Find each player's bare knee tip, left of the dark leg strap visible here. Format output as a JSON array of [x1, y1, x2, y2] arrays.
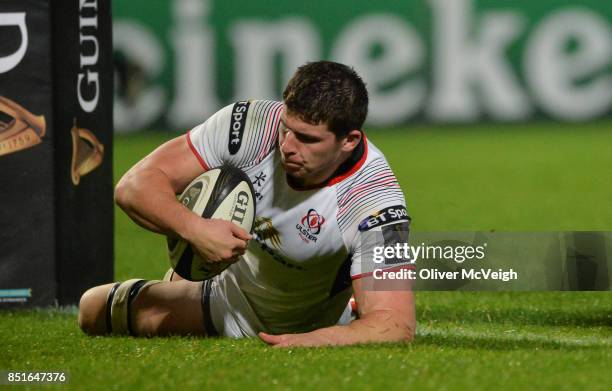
[[79, 284, 113, 335]]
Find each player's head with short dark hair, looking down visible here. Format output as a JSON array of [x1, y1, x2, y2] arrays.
[[279, 61, 368, 186]]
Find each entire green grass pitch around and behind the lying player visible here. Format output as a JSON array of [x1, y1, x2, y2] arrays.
[[0, 123, 612, 390]]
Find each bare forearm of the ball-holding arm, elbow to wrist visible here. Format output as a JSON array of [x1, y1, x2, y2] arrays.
[[115, 169, 193, 236]]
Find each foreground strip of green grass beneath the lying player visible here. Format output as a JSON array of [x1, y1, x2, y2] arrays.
[[0, 292, 612, 390]]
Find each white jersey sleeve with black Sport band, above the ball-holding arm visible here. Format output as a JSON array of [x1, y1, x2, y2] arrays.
[[187, 100, 282, 170]]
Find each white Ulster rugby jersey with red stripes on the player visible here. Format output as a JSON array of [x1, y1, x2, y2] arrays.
[[187, 100, 409, 335]]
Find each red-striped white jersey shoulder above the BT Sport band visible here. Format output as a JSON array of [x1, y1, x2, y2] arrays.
[[336, 140, 407, 234]]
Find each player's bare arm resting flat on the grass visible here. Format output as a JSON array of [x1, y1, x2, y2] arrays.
[[259, 276, 416, 347]]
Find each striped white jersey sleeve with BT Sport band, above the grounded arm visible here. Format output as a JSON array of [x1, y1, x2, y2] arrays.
[[337, 157, 412, 279]]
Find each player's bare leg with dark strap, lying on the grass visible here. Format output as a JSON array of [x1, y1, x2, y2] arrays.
[[79, 280, 204, 336]]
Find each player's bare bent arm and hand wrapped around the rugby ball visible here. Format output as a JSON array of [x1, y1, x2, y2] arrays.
[[115, 136, 250, 261]]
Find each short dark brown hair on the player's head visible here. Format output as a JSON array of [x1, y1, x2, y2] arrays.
[[283, 61, 368, 139]]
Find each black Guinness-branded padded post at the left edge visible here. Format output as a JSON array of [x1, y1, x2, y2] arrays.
[[0, 0, 113, 307]]
